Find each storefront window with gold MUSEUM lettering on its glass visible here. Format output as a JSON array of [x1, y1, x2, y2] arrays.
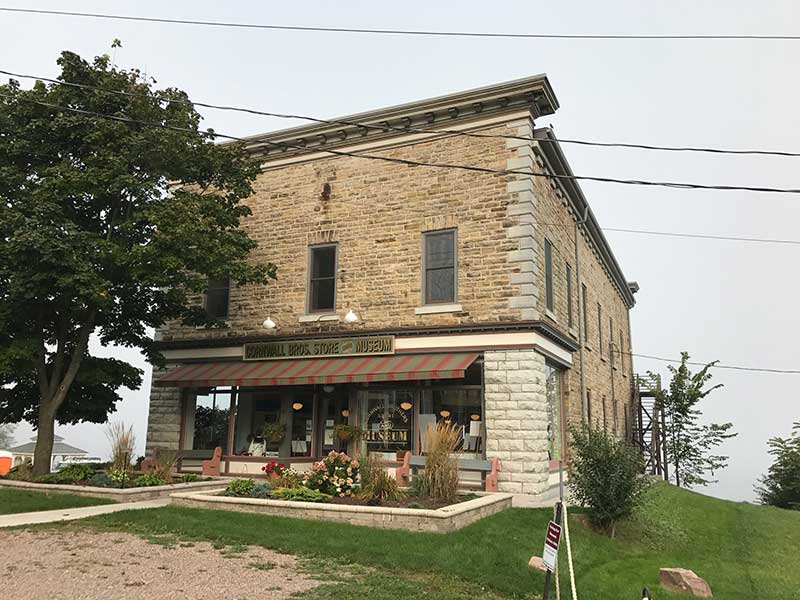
[[361, 389, 416, 453]]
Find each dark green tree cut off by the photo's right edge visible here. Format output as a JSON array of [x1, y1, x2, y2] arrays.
[[756, 421, 800, 510]]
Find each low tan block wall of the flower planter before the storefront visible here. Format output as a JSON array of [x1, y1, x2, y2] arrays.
[[170, 489, 512, 533]]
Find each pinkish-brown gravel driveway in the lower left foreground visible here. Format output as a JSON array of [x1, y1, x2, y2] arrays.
[[0, 530, 320, 600]]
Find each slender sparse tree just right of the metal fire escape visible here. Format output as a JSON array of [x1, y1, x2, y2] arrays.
[[658, 352, 736, 487]]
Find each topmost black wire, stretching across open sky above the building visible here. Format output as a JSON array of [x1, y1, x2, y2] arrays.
[[0, 7, 800, 41]]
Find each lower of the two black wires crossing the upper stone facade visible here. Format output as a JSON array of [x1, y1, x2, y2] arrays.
[[0, 94, 800, 194]]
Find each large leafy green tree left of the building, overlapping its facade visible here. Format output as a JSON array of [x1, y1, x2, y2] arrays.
[[0, 52, 275, 474]]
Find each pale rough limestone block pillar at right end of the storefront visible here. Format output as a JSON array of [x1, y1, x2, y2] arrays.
[[483, 350, 549, 494]]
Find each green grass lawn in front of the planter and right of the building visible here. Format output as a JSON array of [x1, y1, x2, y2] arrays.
[[83, 484, 800, 600]]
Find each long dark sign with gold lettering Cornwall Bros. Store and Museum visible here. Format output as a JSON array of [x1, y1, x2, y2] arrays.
[[242, 335, 394, 360]]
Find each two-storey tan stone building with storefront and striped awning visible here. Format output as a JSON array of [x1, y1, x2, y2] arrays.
[[147, 75, 637, 506]]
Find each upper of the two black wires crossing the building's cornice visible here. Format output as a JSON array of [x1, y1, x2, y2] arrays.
[[6, 69, 800, 157]]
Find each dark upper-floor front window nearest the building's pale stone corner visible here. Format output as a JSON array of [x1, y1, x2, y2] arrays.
[[422, 229, 457, 304]]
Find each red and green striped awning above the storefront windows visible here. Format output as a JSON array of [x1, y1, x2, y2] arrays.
[[153, 353, 478, 387]]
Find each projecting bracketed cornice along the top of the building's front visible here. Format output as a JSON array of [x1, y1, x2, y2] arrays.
[[230, 75, 558, 163]]
